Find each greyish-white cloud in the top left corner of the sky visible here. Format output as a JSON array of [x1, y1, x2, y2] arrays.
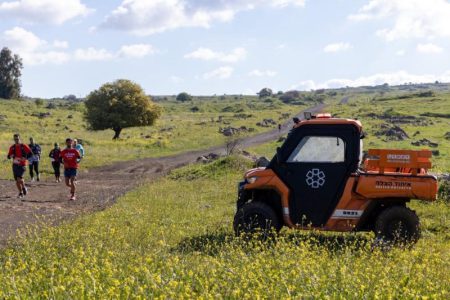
[[0, 0, 92, 24]]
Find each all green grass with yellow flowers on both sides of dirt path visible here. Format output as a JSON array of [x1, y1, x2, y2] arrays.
[[0, 86, 450, 299]]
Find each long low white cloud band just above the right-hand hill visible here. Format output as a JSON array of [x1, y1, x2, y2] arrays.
[[291, 70, 450, 90]]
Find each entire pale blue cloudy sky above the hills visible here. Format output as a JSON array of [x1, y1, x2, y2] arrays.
[[0, 0, 450, 97]]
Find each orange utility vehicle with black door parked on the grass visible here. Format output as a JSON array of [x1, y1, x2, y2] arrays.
[[234, 114, 438, 242]]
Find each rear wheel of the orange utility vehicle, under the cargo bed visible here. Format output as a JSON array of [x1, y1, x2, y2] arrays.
[[375, 206, 420, 245]]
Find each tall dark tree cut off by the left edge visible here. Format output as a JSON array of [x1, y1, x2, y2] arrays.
[[0, 47, 23, 99]]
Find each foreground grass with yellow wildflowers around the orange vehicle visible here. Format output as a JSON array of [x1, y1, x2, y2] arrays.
[[0, 158, 450, 299]]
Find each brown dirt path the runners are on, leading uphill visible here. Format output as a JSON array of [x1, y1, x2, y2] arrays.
[[0, 105, 324, 246]]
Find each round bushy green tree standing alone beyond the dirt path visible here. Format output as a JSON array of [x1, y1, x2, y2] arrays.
[[85, 79, 161, 139]]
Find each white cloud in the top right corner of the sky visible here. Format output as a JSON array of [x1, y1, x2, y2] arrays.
[[348, 0, 450, 41]]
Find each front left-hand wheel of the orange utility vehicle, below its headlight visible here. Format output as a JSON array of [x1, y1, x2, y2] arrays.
[[233, 202, 282, 240]]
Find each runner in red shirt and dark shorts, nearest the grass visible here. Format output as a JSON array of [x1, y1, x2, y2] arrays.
[[59, 138, 81, 201]]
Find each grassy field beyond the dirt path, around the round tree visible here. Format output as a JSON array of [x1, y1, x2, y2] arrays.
[[0, 96, 307, 178]]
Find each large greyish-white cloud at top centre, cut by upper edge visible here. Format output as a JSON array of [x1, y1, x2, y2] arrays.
[[100, 0, 305, 35]]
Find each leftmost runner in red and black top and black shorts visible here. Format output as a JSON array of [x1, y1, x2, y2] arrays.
[[8, 133, 32, 198]]
